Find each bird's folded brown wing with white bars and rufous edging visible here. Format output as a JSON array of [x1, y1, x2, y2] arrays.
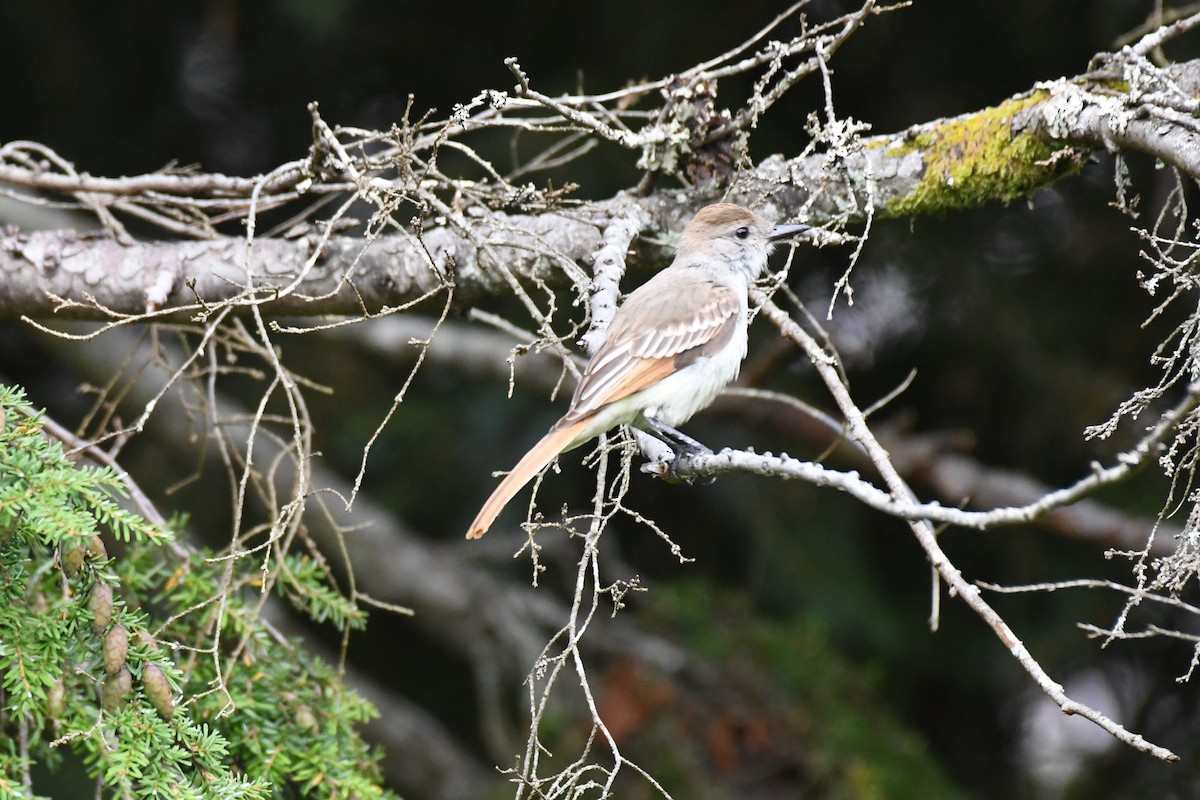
[[563, 270, 740, 423]]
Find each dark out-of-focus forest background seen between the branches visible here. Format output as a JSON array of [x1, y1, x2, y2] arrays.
[[0, 0, 1200, 799]]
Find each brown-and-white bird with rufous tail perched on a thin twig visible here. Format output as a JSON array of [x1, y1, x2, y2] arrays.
[[467, 203, 810, 539]]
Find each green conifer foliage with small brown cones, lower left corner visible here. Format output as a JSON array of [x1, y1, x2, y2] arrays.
[[0, 386, 390, 799]]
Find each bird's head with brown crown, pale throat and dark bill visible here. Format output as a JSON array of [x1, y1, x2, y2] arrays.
[[676, 203, 809, 279]]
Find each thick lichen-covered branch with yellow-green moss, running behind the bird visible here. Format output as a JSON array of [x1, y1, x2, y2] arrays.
[[7, 52, 1200, 321]]
